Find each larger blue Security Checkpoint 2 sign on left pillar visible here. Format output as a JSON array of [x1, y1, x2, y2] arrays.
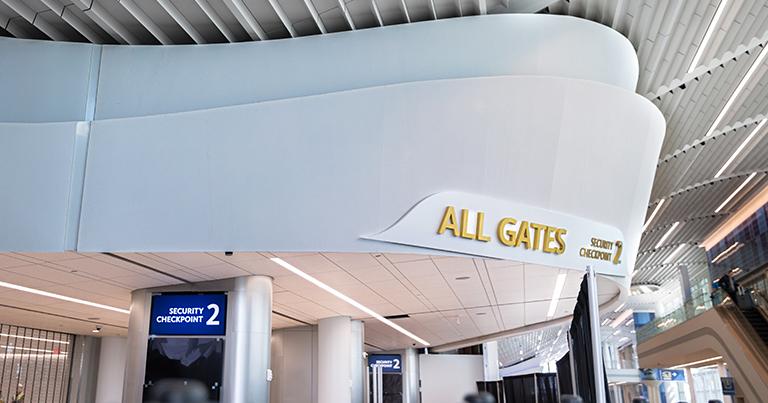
[[149, 293, 227, 336]]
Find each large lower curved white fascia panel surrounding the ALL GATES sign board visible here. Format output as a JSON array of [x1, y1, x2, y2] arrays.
[[79, 77, 664, 290]]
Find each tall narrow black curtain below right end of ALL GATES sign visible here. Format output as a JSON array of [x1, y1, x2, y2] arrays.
[[558, 275, 611, 403]]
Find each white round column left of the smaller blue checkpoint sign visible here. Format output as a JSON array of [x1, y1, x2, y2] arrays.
[[317, 316, 353, 403]]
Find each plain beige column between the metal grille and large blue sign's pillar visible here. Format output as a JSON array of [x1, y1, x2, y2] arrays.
[[96, 337, 128, 403]]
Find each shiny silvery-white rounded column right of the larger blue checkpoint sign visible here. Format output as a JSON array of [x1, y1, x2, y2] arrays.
[[222, 276, 272, 403]]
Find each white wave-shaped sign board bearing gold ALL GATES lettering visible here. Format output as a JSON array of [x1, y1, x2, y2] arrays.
[[363, 192, 628, 277]]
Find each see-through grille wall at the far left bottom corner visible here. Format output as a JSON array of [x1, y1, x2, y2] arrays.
[[0, 324, 74, 403]]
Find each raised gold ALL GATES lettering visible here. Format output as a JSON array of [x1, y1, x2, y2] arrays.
[[437, 206, 568, 255]]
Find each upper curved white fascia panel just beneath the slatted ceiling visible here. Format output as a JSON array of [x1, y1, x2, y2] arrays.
[[96, 14, 638, 119]]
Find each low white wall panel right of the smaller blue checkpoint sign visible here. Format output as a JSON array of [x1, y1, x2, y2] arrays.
[[419, 354, 483, 403]]
